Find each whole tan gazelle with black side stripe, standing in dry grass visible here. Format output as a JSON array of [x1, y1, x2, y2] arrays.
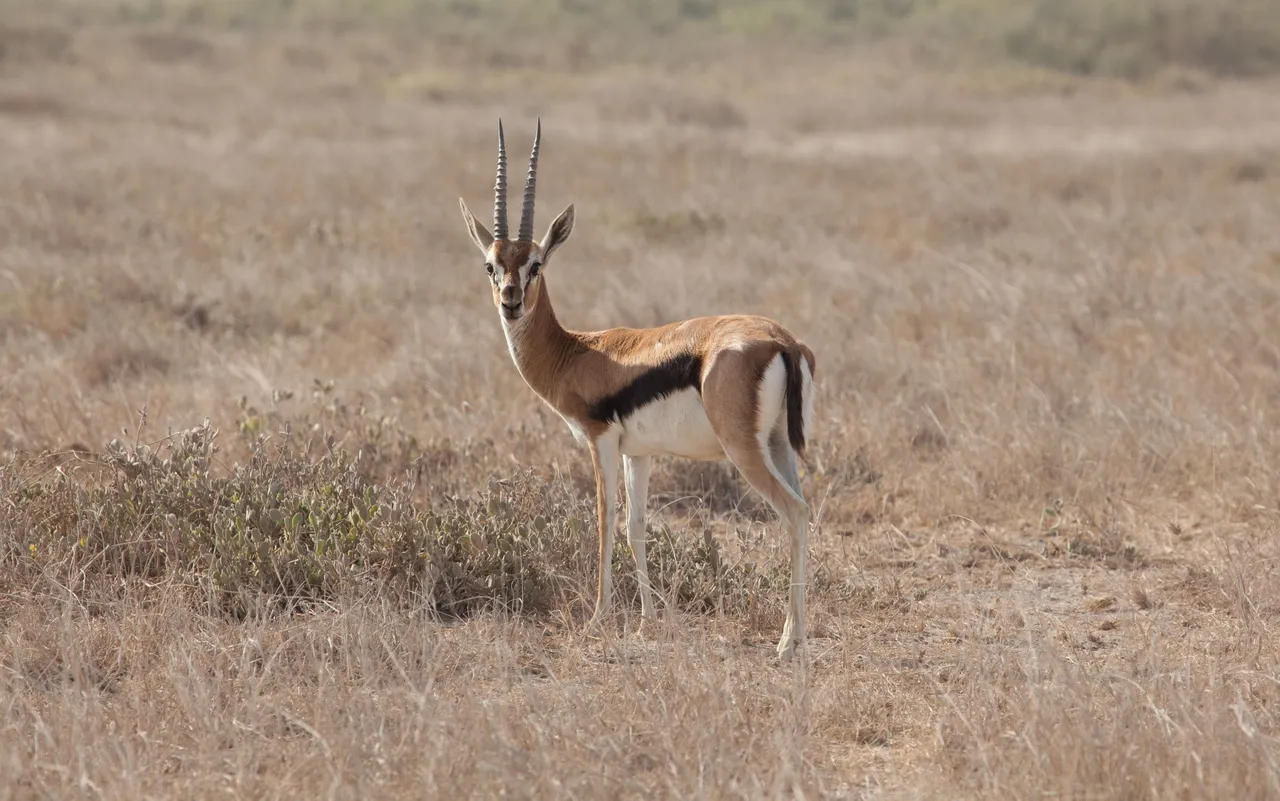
[[458, 120, 814, 660]]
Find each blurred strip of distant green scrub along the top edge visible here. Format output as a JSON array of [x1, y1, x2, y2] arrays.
[[17, 0, 1280, 79]]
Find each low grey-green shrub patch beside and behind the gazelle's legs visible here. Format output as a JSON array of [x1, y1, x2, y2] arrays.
[[0, 421, 787, 618]]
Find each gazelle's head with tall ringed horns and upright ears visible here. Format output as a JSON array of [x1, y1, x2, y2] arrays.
[[458, 119, 573, 324]]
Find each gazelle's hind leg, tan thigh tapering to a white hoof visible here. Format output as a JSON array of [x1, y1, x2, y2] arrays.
[[703, 351, 809, 660]]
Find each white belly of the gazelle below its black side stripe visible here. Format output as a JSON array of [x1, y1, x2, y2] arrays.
[[621, 388, 724, 461]]
